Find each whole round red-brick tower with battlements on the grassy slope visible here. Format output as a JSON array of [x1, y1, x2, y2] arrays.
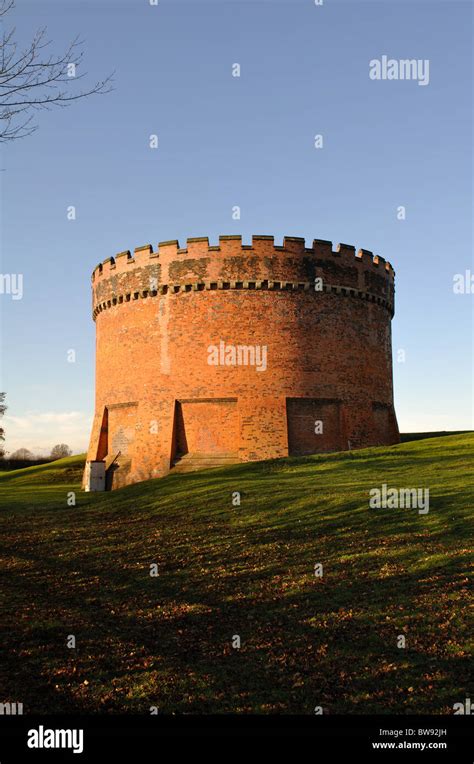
[[87, 236, 399, 488]]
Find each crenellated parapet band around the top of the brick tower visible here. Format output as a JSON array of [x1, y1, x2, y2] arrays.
[[92, 236, 395, 318]]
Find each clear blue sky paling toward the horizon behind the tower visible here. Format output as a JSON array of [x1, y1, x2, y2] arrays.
[[0, 0, 474, 454]]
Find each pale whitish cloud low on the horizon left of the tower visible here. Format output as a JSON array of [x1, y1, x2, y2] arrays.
[[2, 411, 92, 456]]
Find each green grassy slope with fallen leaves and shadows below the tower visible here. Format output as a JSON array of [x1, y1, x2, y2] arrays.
[[0, 434, 474, 714]]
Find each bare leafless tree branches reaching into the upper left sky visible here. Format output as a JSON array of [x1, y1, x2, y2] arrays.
[[0, 0, 112, 142]]
